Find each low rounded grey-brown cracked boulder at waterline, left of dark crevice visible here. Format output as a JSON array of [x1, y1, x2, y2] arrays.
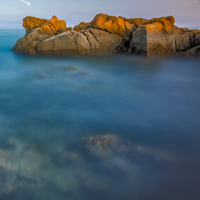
[[37, 29, 122, 55]]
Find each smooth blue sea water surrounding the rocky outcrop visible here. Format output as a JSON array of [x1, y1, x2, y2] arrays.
[[0, 30, 200, 200]]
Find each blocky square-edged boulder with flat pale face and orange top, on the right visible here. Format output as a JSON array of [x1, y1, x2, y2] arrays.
[[129, 16, 176, 56]]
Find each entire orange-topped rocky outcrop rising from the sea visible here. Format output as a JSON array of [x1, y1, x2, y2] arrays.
[[13, 14, 200, 56]]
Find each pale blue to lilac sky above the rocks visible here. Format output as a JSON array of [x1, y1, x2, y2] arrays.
[[0, 0, 200, 29]]
